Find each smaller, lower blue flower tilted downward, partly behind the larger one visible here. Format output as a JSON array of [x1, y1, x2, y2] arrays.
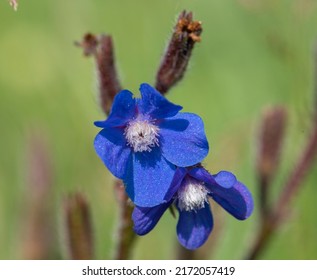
[[132, 167, 253, 250]]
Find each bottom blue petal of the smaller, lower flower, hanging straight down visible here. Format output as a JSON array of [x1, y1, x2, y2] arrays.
[[177, 202, 213, 250]]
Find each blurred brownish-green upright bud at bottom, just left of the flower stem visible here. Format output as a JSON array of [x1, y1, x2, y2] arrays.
[[64, 193, 94, 260]]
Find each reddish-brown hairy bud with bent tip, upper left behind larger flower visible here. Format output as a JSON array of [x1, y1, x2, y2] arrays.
[[75, 33, 122, 114]]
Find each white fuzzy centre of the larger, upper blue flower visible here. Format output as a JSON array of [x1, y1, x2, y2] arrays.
[[124, 120, 159, 152]]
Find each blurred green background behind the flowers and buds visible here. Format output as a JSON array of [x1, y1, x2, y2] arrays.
[[0, 0, 317, 259]]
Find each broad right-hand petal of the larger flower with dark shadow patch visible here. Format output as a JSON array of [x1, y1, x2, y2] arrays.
[[159, 113, 209, 167]]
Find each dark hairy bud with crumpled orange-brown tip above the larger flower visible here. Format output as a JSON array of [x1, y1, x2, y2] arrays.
[[155, 11, 202, 94]]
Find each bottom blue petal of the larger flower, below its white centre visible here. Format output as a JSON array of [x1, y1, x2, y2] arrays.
[[124, 147, 176, 207]]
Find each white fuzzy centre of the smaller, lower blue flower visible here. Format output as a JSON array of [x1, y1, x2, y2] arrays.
[[177, 179, 208, 211]]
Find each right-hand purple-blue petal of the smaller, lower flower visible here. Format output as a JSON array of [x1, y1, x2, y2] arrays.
[[210, 181, 253, 220]]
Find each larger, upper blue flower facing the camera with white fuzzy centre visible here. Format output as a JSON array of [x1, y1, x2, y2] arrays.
[[94, 84, 209, 207]]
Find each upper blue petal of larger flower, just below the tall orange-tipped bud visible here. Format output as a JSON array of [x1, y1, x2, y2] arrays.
[[139, 84, 182, 119]]
